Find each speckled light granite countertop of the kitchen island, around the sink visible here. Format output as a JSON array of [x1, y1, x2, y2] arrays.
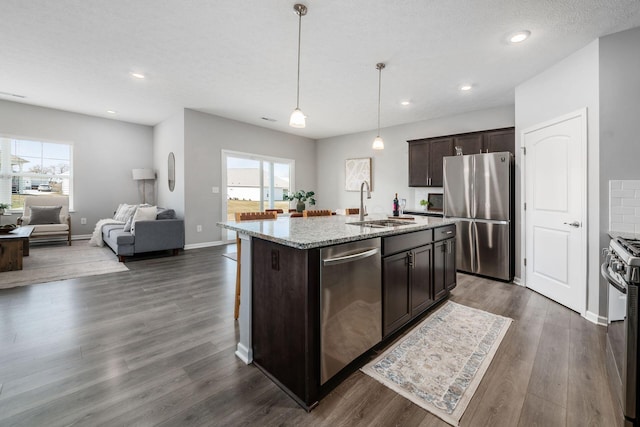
[[217, 214, 455, 249]]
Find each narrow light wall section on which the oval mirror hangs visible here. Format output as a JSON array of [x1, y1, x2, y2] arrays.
[[153, 110, 185, 218]]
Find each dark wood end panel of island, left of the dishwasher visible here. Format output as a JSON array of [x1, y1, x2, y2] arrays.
[[252, 238, 320, 409]]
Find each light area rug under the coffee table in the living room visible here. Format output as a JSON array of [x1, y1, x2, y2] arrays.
[[0, 240, 129, 289]]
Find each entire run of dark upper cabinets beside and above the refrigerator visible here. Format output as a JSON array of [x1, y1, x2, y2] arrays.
[[407, 128, 515, 187]]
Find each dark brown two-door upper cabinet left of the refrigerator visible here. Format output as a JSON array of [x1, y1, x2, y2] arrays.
[[409, 138, 454, 187]]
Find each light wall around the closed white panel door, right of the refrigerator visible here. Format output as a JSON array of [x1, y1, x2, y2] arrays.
[[515, 40, 608, 317]]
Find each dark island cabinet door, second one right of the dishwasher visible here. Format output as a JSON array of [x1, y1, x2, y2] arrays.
[[409, 245, 433, 317]]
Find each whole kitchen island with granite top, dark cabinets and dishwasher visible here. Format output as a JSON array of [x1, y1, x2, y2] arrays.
[[218, 215, 456, 410]]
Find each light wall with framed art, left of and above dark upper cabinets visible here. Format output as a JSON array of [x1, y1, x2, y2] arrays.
[[316, 105, 514, 214]]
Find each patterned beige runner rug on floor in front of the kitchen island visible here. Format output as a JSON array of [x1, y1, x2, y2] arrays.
[[361, 301, 513, 426]]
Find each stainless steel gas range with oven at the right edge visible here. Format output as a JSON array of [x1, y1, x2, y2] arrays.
[[600, 237, 640, 426]]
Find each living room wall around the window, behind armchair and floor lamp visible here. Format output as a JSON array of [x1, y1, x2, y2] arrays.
[[0, 100, 153, 235]]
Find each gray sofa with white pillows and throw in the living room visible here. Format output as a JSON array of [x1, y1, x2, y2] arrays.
[[102, 211, 184, 262]]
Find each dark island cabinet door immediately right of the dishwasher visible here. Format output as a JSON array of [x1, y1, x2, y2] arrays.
[[382, 252, 411, 337]]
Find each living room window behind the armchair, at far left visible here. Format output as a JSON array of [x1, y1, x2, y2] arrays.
[[0, 137, 73, 210]]
